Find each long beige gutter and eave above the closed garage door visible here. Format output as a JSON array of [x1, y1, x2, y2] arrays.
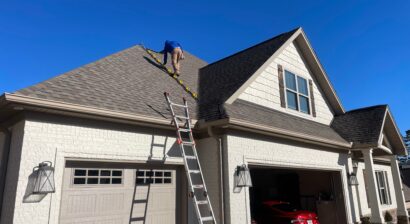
[[0, 93, 187, 129]]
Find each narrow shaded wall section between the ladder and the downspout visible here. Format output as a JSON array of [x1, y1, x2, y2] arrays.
[[196, 138, 222, 223]]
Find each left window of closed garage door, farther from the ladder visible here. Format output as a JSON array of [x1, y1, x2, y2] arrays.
[[72, 169, 123, 185]]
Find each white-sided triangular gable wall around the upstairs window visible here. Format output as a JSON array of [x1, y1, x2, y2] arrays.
[[239, 43, 333, 124]]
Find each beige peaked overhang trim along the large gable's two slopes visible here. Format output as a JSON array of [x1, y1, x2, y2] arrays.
[[225, 28, 345, 115]]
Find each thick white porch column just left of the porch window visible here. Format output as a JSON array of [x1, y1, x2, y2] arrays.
[[362, 149, 384, 224]]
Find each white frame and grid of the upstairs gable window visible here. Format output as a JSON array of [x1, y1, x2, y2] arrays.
[[283, 68, 312, 116]]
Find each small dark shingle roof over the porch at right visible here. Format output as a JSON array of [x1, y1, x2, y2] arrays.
[[331, 105, 387, 145]]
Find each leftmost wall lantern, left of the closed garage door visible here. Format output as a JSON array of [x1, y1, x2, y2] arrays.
[[33, 161, 55, 194]]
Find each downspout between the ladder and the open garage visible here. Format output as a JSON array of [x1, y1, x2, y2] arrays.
[[208, 126, 226, 224]]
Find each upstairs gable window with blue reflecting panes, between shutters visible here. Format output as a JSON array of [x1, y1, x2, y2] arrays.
[[285, 70, 310, 114]]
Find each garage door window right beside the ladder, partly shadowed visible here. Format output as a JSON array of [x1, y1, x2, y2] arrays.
[[136, 170, 172, 184]]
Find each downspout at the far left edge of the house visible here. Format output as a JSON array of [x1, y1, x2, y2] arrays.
[[0, 125, 12, 219]]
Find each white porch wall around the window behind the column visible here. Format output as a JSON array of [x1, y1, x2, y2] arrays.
[[356, 162, 397, 216]]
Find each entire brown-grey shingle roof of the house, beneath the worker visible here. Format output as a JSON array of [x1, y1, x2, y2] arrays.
[[15, 29, 386, 149]]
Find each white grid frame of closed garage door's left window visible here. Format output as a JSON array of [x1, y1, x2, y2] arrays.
[[70, 168, 124, 187]]
